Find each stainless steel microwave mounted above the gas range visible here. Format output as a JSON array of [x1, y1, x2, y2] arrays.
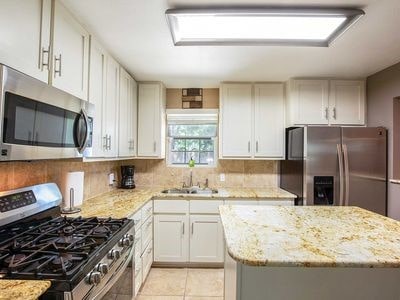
[[0, 65, 94, 161]]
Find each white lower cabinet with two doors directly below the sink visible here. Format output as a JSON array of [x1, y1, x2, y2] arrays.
[[154, 200, 224, 263]]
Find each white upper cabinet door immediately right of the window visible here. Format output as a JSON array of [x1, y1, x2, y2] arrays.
[[220, 84, 253, 158]]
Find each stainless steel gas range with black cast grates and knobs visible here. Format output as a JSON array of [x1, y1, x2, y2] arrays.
[[0, 184, 135, 300]]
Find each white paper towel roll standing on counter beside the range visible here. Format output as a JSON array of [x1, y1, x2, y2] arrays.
[[61, 172, 85, 208]]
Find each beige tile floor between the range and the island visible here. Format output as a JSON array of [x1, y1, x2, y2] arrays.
[[136, 268, 224, 300]]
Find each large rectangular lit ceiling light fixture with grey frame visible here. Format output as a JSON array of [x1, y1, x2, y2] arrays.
[[165, 8, 364, 47]]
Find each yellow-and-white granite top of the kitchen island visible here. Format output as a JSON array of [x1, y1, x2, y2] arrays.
[[220, 205, 400, 268]]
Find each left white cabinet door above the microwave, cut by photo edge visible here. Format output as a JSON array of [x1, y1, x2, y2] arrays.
[[0, 0, 51, 83]]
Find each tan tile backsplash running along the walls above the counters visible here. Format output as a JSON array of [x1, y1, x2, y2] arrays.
[[0, 160, 278, 199]]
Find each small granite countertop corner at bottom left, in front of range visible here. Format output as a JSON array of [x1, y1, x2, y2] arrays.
[[0, 279, 51, 300]]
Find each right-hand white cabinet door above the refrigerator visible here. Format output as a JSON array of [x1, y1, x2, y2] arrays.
[[329, 80, 365, 125]]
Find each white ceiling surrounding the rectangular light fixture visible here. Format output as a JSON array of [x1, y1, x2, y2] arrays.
[[63, 0, 400, 87]]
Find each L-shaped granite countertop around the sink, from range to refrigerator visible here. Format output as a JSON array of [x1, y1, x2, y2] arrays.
[[67, 187, 296, 218]]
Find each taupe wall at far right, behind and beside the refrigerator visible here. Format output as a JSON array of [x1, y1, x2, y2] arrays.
[[367, 63, 400, 220]]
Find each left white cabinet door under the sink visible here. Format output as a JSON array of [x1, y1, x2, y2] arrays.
[[154, 215, 189, 262]]
